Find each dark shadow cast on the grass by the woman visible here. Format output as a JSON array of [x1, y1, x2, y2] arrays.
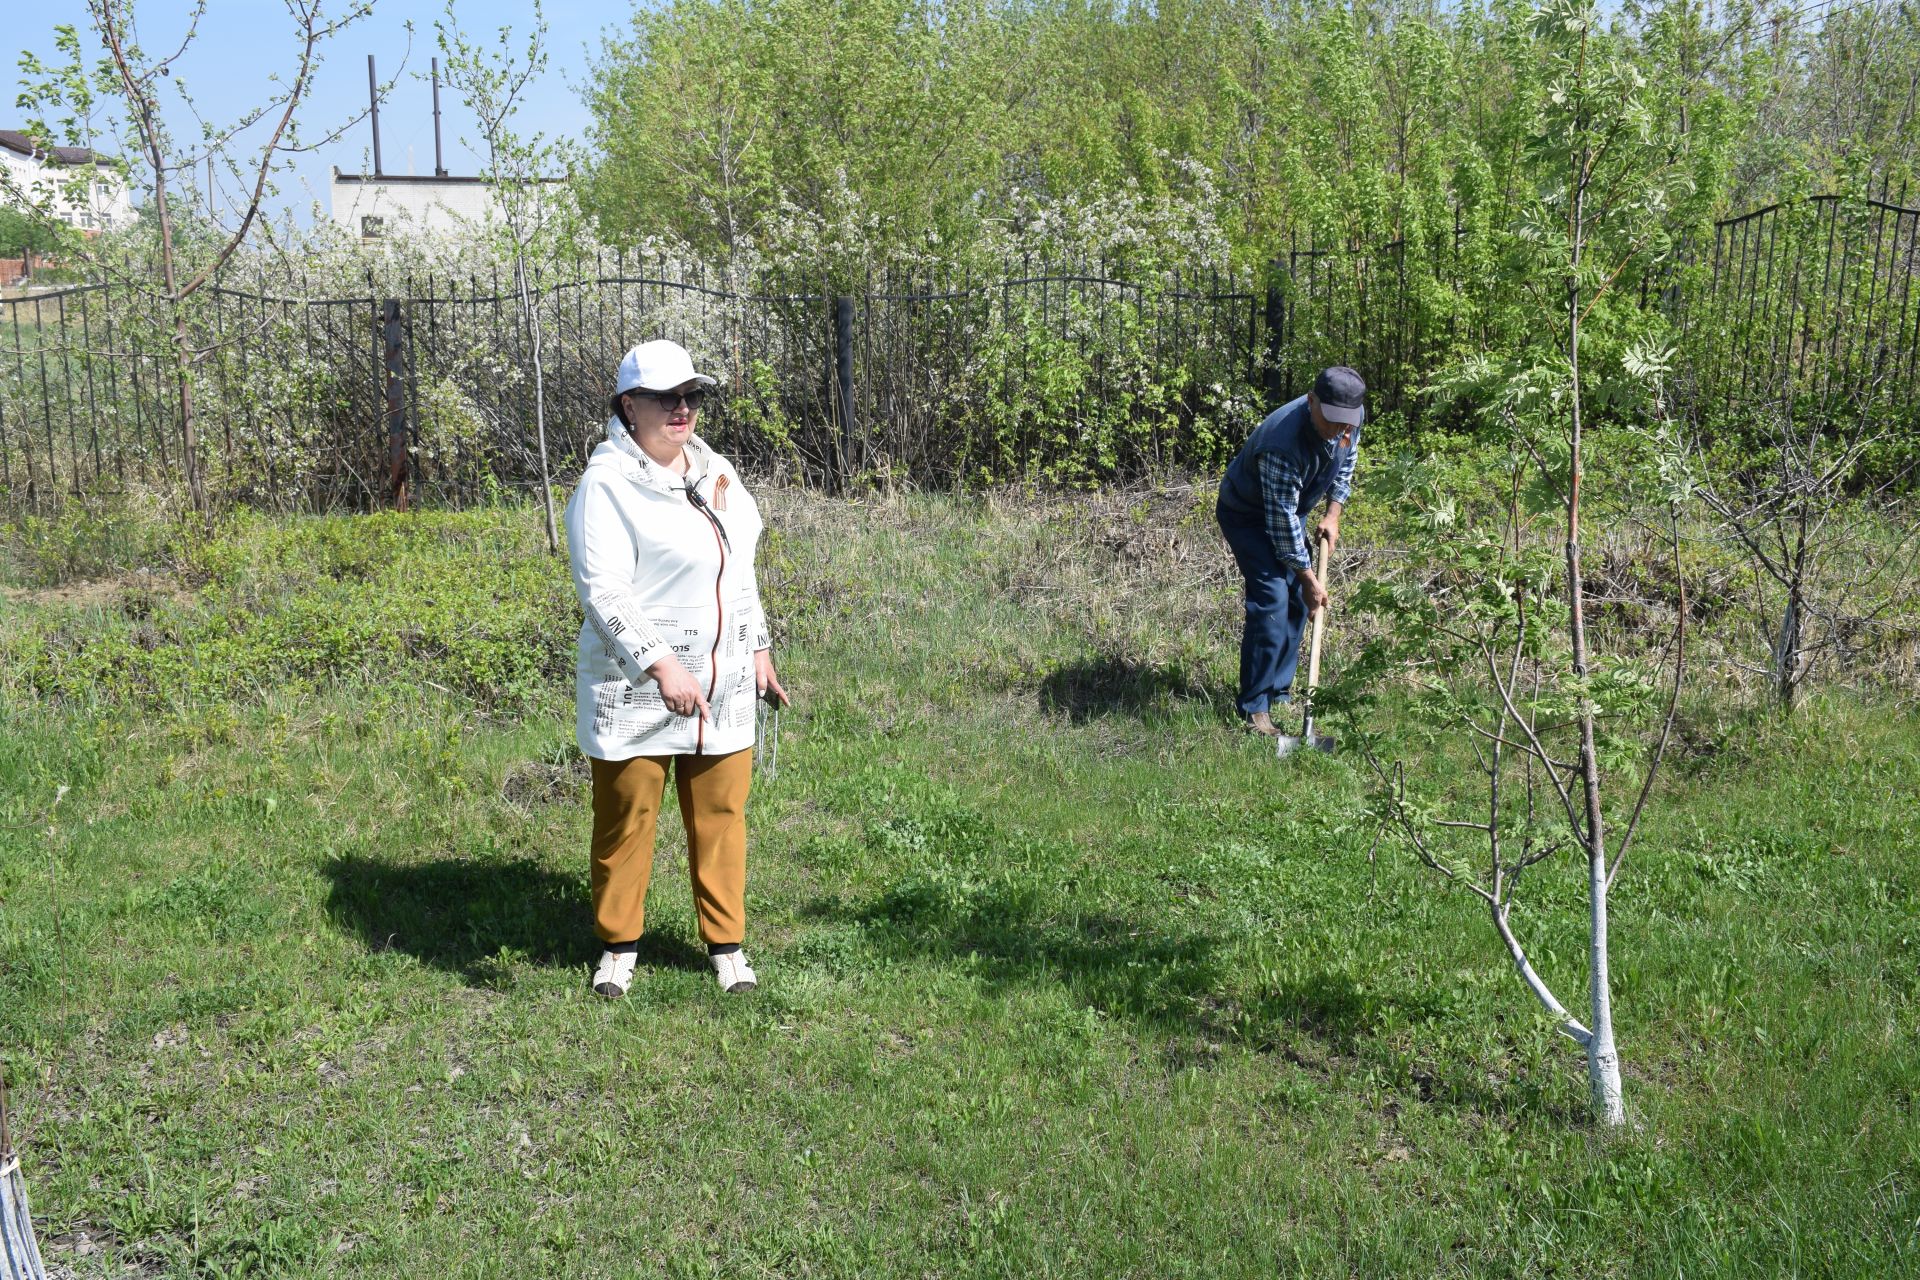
[[323, 856, 707, 984]]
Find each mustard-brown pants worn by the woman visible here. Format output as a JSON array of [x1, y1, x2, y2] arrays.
[[589, 748, 753, 944]]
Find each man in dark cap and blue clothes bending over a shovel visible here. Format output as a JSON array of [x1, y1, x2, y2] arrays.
[[1213, 365, 1367, 737]]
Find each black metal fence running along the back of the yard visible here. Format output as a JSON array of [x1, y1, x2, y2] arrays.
[[0, 198, 1920, 509]]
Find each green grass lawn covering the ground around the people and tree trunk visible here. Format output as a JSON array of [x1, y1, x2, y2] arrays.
[[0, 491, 1920, 1278]]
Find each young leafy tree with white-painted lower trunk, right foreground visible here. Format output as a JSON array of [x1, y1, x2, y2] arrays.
[[1356, 0, 1690, 1126]]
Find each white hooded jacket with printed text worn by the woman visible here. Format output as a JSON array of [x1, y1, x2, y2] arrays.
[[566, 418, 772, 760]]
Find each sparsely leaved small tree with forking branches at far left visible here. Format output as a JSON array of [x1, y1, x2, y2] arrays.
[[9, 0, 393, 514]]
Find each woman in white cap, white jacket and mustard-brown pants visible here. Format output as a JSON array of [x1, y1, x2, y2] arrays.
[[566, 342, 787, 996]]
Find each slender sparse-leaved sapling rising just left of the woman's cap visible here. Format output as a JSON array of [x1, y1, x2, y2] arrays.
[[436, 0, 578, 553]]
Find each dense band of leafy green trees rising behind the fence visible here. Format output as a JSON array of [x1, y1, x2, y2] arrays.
[[586, 0, 1881, 280]]
